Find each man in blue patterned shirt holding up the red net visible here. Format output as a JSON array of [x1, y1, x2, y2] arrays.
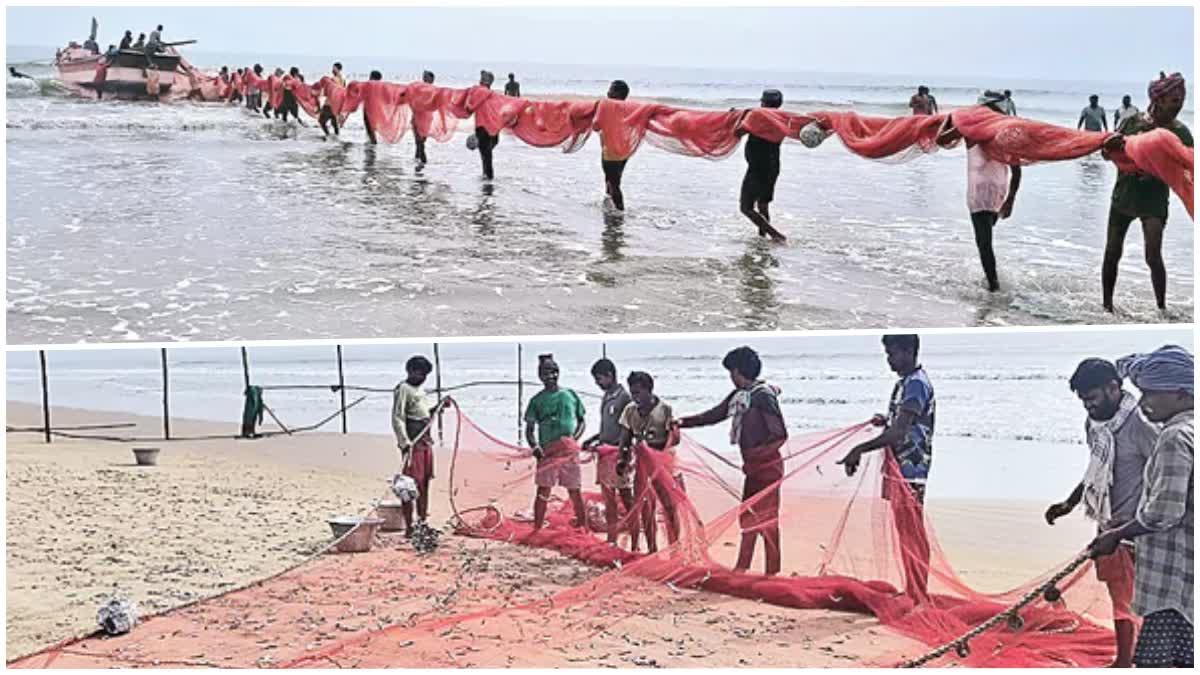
[[838, 335, 936, 597]]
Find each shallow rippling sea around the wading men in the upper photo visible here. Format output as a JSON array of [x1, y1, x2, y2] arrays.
[[6, 54, 1194, 344]]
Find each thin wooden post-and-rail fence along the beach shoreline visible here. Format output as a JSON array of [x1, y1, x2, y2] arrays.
[[6, 342, 607, 446]]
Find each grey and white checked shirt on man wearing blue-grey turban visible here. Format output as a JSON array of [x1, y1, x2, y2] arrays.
[[1133, 411, 1195, 626]]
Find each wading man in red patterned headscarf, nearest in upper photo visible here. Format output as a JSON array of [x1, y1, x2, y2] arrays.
[[1100, 73, 1193, 312]]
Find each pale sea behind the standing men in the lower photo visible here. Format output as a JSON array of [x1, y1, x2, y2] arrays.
[[6, 327, 1193, 501]]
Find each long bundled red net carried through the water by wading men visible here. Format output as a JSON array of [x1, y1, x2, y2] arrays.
[[174, 63, 1195, 214]]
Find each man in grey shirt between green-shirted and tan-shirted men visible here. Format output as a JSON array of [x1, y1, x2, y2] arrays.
[[583, 358, 637, 545]]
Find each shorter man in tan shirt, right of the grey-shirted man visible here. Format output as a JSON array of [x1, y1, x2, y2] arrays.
[[617, 370, 684, 552]]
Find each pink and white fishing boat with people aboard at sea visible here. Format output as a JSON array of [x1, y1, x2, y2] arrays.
[[54, 19, 196, 101]]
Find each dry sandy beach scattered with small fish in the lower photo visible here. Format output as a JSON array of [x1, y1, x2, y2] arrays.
[[6, 402, 1099, 667]]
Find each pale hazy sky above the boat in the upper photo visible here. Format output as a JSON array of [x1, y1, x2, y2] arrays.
[[5, 6, 1194, 82]]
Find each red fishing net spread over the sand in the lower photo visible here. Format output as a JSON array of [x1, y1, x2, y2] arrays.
[[14, 404, 1114, 668]]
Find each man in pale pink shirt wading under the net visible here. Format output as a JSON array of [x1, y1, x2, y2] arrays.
[[938, 89, 1021, 293]]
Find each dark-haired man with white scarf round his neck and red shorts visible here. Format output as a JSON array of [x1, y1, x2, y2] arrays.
[[1045, 359, 1158, 668]]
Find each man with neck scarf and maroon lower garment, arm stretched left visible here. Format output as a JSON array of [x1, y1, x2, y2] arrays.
[[678, 347, 787, 575]]
